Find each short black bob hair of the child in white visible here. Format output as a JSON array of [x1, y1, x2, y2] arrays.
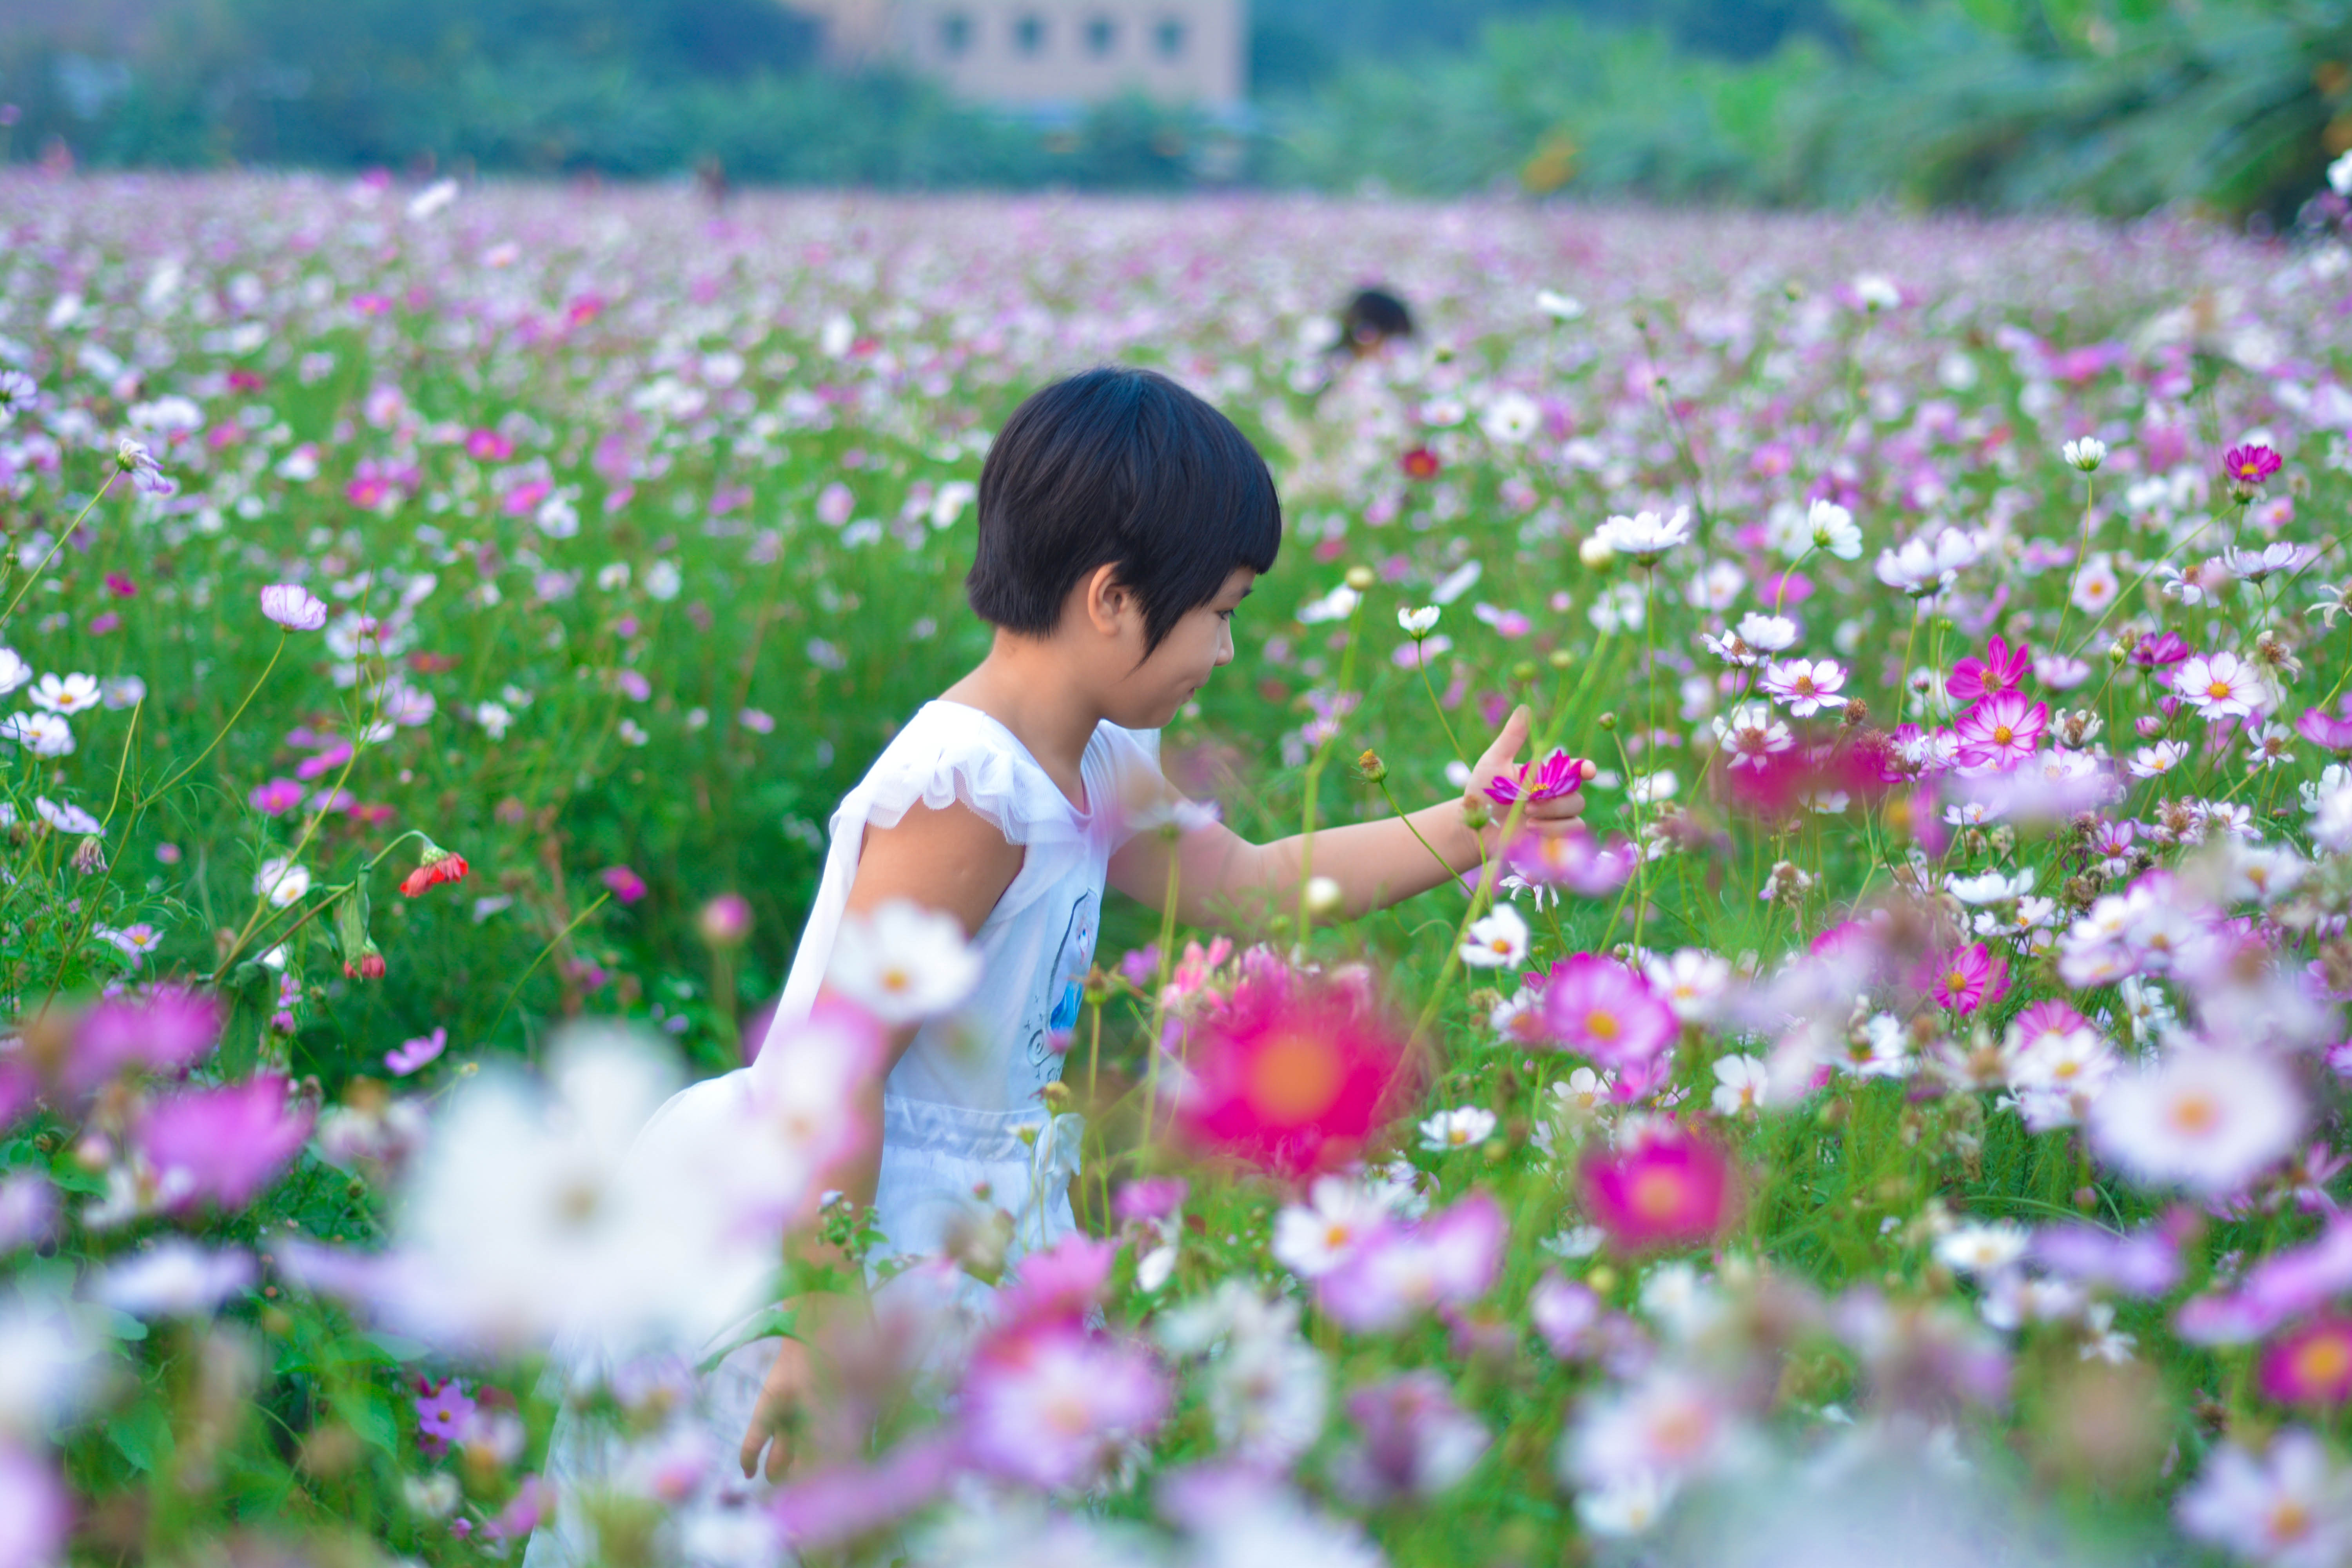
[[964, 365, 1282, 653]]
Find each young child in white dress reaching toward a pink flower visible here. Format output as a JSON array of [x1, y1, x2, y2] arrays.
[[532, 369, 1581, 1568]]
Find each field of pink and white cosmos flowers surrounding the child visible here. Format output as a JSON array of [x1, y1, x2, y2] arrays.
[[0, 167, 2352, 1568]]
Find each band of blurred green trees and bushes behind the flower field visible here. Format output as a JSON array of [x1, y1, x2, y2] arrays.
[[0, 0, 2352, 219]]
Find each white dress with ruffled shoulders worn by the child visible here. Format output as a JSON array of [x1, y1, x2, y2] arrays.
[[524, 698, 1164, 1568]]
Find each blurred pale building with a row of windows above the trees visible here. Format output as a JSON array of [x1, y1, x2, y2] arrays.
[[786, 0, 1249, 108]]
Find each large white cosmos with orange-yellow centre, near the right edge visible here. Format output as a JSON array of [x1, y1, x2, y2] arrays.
[[2091, 1042, 2303, 1194]]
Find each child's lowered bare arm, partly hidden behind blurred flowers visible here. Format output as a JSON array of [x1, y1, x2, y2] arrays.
[[739, 804, 1023, 1481]]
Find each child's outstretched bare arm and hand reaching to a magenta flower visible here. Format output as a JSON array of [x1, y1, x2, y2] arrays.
[[1110, 708, 1592, 926]]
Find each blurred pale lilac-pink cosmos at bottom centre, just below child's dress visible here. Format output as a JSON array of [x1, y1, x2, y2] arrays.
[[962, 1328, 1169, 1490]]
